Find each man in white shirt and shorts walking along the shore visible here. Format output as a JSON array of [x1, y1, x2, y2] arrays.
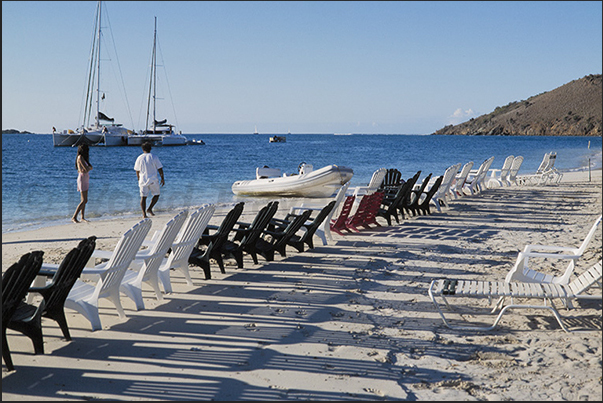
[[134, 141, 165, 218]]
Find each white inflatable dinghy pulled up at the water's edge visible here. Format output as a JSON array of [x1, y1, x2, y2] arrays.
[[232, 162, 354, 197]]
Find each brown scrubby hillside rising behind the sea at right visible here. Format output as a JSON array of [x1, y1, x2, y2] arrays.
[[432, 74, 603, 136]]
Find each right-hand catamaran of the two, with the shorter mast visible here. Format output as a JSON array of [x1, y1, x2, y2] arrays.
[[128, 17, 188, 146]]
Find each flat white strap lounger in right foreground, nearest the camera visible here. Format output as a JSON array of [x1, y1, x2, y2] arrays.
[[428, 261, 601, 332]]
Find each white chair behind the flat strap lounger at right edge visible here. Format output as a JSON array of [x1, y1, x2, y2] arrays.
[[505, 216, 603, 284]]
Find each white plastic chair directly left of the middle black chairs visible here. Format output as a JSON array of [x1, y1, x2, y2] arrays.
[[159, 204, 216, 293]]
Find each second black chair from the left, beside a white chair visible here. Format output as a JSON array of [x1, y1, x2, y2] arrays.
[[8, 236, 96, 354]]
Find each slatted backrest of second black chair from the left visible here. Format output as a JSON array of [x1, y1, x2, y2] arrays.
[[44, 236, 96, 311]]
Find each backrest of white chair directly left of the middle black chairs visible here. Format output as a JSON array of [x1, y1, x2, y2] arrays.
[[167, 204, 216, 268]]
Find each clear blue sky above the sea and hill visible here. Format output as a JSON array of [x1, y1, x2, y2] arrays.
[[2, 1, 603, 134]]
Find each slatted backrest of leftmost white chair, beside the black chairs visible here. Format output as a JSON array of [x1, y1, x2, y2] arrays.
[[95, 218, 153, 298]]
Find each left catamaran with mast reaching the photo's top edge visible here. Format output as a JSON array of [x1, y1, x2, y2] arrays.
[[52, 1, 133, 147]]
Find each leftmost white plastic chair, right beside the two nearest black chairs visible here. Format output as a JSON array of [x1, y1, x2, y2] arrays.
[[65, 218, 152, 330]]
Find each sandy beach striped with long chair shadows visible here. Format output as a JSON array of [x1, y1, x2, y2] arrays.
[[2, 170, 603, 401]]
